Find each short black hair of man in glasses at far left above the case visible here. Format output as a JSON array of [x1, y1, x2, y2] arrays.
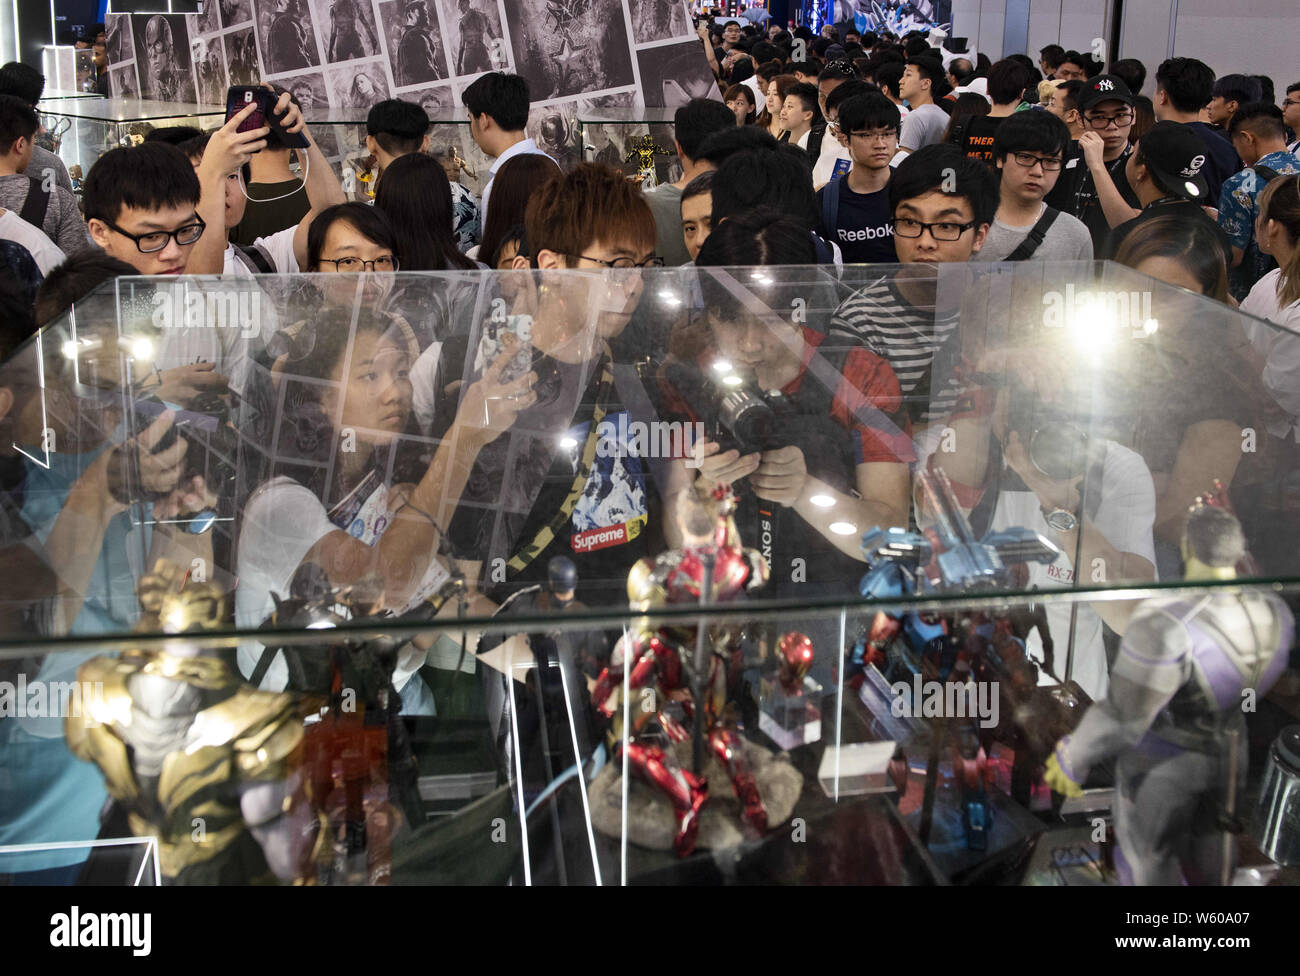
[[82, 143, 199, 221]]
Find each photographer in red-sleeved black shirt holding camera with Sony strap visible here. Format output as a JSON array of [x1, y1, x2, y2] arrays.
[[664, 211, 913, 594]]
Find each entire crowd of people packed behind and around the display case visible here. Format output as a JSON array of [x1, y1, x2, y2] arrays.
[[0, 22, 1300, 879]]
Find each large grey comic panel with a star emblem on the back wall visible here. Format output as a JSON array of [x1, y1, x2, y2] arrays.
[[506, 0, 634, 101]]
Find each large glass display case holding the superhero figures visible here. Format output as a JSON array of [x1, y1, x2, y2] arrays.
[[0, 263, 1300, 885]]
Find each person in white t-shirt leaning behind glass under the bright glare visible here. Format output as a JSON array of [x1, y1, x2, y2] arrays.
[[918, 347, 1156, 699]]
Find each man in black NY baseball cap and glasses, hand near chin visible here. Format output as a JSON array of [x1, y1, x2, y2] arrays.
[[1045, 74, 1138, 253]]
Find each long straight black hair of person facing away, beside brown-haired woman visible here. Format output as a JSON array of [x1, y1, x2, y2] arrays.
[[374, 152, 477, 272]]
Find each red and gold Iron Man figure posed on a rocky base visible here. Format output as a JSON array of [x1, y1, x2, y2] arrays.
[[592, 485, 807, 856]]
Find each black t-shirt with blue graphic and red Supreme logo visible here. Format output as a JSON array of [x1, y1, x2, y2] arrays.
[[447, 356, 654, 607]]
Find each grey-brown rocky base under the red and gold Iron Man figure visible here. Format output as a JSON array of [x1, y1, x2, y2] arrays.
[[590, 739, 803, 851]]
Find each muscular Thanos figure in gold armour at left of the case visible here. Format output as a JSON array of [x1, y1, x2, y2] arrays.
[[66, 561, 317, 884]]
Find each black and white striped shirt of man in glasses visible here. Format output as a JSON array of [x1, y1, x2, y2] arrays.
[[827, 278, 961, 424]]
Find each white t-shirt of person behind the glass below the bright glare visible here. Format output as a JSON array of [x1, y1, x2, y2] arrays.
[[922, 425, 1156, 700]]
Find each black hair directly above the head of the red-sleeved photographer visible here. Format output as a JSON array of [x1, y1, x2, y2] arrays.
[[712, 143, 818, 231]]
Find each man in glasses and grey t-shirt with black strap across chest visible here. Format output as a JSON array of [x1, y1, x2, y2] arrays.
[[975, 112, 1092, 261]]
